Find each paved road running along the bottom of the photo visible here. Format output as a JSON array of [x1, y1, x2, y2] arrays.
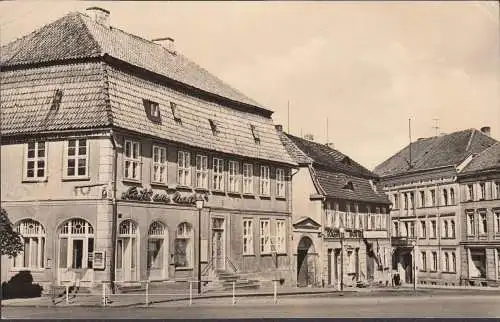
[[2, 295, 500, 319]]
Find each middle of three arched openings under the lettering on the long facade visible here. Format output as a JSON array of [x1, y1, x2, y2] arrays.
[[147, 221, 168, 279]]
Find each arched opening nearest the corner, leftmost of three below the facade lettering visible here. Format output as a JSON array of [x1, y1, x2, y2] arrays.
[[116, 219, 138, 281]]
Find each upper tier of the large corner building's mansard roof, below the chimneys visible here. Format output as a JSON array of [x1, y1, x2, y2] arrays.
[[0, 12, 265, 110]]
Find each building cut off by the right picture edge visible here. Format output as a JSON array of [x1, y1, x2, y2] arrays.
[[458, 143, 500, 286]]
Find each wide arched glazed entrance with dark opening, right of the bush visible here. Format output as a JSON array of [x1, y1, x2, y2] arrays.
[[57, 219, 94, 287]]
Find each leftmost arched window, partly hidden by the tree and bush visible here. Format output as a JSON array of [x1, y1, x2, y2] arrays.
[[13, 219, 45, 268]]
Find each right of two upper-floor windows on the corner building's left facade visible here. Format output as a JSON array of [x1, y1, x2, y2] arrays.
[[64, 139, 88, 178]]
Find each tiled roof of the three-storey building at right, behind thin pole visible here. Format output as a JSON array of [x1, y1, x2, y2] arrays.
[[374, 129, 497, 177]]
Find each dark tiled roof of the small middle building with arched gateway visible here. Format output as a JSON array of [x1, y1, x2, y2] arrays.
[[278, 131, 390, 204]]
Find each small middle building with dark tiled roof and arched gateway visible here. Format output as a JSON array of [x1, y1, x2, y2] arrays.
[[277, 126, 391, 288]]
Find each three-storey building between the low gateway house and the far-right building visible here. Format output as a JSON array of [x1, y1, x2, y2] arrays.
[[374, 129, 496, 285]]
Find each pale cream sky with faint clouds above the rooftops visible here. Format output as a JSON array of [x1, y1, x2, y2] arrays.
[[0, 1, 500, 169]]
